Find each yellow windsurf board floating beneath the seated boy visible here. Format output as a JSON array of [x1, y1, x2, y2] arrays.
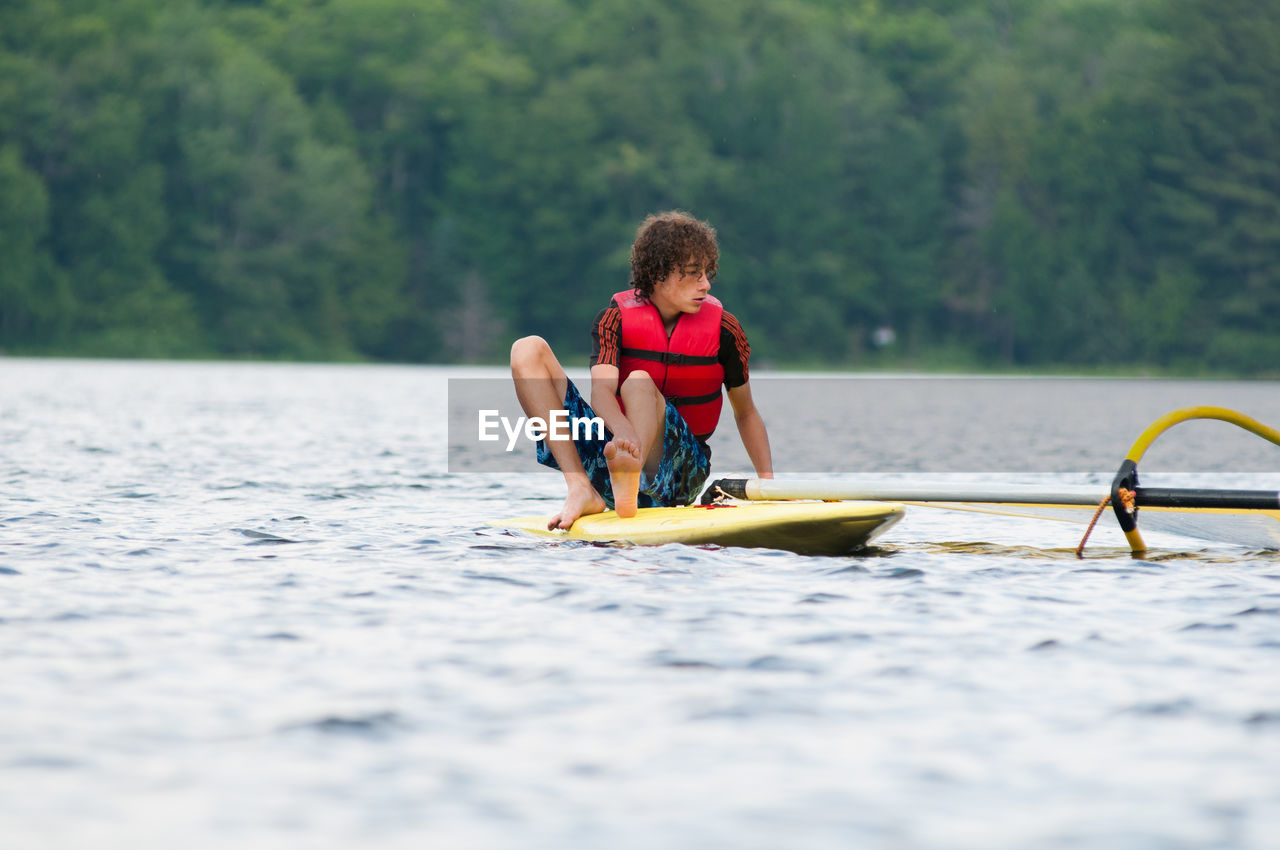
[[489, 502, 904, 554]]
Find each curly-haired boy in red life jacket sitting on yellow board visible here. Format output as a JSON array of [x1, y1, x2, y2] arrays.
[[511, 211, 773, 529]]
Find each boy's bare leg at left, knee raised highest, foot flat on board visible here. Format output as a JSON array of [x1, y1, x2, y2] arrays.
[[511, 337, 604, 529]]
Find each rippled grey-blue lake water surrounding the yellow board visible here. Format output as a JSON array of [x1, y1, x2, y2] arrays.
[[0, 358, 1280, 850]]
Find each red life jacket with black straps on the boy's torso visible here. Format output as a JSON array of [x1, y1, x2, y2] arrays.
[[613, 289, 724, 439]]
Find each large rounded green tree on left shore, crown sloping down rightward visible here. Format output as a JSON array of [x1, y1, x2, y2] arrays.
[[148, 8, 402, 357]]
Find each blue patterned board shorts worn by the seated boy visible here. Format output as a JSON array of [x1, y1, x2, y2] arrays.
[[538, 381, 712, 508]]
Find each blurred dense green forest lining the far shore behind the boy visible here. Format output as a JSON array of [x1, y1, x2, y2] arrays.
[[0, 0, 1280, 374]]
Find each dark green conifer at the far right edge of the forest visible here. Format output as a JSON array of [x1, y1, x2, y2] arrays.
[[1157, 0, 1280, 371]]
